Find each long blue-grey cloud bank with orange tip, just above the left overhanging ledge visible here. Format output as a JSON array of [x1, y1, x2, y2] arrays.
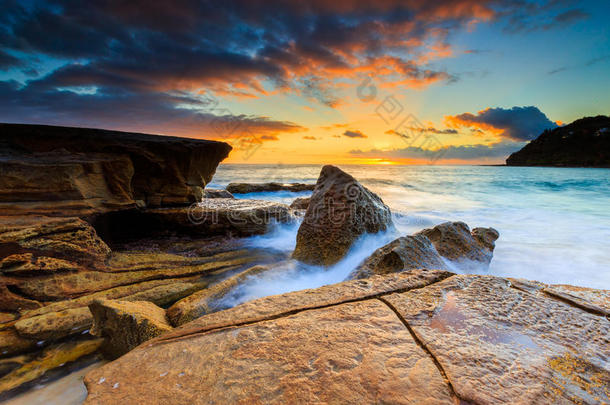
[[0, 82, 306, 140]]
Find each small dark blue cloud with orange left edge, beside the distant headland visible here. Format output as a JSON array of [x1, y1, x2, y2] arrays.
[[445, 106, 557, 141]]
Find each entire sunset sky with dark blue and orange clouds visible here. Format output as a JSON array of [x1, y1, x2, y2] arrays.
[[0, 0, 610, 164]]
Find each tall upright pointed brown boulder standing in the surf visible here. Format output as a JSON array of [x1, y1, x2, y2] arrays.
[[293, 165, 393, 266]]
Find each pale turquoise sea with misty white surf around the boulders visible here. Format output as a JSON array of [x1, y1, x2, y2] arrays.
[[210, 165, 610, 290]]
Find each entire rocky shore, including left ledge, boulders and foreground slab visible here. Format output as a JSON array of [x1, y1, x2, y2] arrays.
[[0, 124, 610, 404]]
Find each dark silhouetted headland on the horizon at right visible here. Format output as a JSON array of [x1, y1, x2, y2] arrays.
[[506, 115, 610, 167]]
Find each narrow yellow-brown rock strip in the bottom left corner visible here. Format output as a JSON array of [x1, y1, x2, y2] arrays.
[[0, 339, 102, 395]]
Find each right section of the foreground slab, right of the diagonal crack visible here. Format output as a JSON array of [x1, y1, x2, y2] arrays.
[[384, 275, 610, 404]]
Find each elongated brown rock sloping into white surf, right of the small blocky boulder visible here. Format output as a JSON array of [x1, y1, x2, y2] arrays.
[[167, 266, 269, 326]]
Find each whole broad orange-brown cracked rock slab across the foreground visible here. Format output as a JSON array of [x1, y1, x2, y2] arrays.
[[85, 270, 610, 404]]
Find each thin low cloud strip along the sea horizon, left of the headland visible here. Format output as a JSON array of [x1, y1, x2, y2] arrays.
[[349, 141, 524, 161]]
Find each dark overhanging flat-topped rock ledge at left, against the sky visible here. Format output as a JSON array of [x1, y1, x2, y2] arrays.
[[0, 124, 231, 217]]
